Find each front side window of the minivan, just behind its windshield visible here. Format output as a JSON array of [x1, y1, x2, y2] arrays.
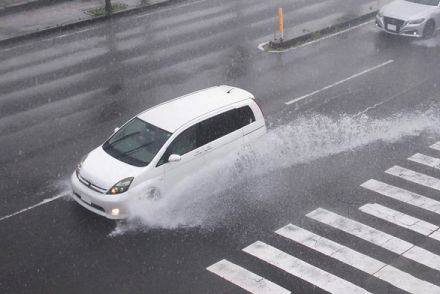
[[157, 125, 197, 166]]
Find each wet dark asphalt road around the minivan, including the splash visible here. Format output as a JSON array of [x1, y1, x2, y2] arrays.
[[0, 1, 440, 294]]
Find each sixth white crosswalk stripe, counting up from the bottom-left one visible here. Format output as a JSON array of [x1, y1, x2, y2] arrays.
[[361, 179, 440, 214]]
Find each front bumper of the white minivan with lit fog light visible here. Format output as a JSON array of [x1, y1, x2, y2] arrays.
[[71, 172, 129, 219]]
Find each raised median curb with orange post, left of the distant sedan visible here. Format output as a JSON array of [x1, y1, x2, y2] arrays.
[[268, 10, 378, 50]]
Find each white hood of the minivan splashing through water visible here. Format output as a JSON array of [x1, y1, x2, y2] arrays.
[[80, 146, 142, 189]]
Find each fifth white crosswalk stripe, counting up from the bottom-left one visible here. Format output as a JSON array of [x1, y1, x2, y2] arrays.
[[359, 203, 439, 236]]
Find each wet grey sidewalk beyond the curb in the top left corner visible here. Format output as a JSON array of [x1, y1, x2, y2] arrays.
[[0, 0, 174, 45]]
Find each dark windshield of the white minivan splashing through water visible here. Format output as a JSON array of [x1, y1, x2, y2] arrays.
[[102, 117, 171, 167]]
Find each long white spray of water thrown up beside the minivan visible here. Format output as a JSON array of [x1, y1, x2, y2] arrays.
[[111, 107, 440, 236]]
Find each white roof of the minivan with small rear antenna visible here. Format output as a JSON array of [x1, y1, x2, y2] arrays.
[[137, 85, 253, 133]]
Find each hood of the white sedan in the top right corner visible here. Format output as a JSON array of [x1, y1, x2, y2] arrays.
[[382, 0, 437, 21]]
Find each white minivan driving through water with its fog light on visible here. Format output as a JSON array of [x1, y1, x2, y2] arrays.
[[71, 86, 266, 219]]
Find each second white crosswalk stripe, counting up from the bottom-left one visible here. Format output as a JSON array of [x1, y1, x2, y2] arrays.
[[243, 241, 369, 294]]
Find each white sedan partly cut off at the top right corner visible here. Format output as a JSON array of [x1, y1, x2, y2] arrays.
[[376, 0, 440, 37]]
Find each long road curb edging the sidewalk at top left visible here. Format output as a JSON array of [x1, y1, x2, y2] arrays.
[[0, 0, 185, 47]]
